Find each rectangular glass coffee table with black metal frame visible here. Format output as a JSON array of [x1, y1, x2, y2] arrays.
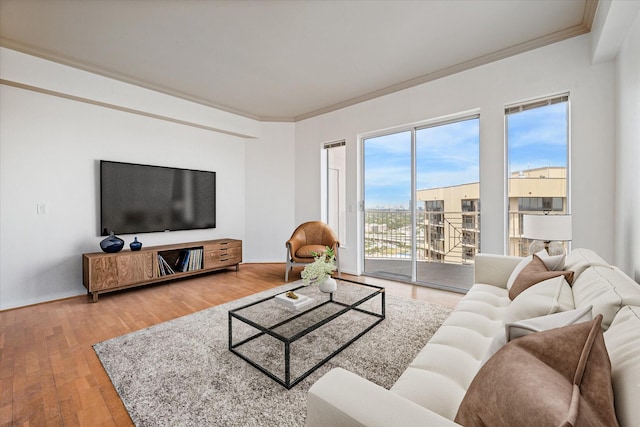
[[229, 278, 385, 389]]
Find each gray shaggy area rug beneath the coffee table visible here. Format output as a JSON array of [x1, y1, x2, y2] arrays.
[[94, 284, 451, 427]]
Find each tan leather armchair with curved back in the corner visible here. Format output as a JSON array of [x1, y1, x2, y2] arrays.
[[284, 221, 340, 282]]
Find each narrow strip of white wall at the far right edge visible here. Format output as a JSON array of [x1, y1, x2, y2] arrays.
[[615, 12, 640, 282]]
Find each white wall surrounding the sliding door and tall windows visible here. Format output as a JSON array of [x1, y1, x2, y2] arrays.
[[295, 35, 615, 278]]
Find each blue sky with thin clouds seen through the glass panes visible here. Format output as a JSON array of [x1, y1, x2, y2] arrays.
[[364, 103, 567, 209]]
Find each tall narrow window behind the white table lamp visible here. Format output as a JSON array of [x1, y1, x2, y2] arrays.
[[505, 94, 570, 256]]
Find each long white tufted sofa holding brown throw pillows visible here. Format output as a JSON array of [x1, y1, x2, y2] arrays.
[[306, 249, 640, 427]]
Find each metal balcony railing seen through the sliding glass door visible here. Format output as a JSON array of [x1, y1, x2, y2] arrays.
[[364, 209, 480, 264]]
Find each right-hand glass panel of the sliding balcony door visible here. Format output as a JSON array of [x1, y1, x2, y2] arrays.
[[415, 117, 480, 290]]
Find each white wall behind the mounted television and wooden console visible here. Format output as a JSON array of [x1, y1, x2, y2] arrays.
[[0, 49, 293, 309]]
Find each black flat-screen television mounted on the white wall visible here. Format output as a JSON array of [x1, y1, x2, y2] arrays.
[[100, 160, 216, 236]]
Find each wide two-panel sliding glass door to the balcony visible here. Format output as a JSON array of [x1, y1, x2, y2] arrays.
[[362, 116, 480, 290]]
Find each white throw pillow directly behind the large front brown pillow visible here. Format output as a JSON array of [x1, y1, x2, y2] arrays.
[[482, 306, 593, 365]]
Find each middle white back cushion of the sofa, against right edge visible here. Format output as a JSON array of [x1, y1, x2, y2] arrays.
[[573, 266, 640, 330]]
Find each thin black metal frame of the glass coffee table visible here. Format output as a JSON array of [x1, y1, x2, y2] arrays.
[[229, 278, 385, 390]]
